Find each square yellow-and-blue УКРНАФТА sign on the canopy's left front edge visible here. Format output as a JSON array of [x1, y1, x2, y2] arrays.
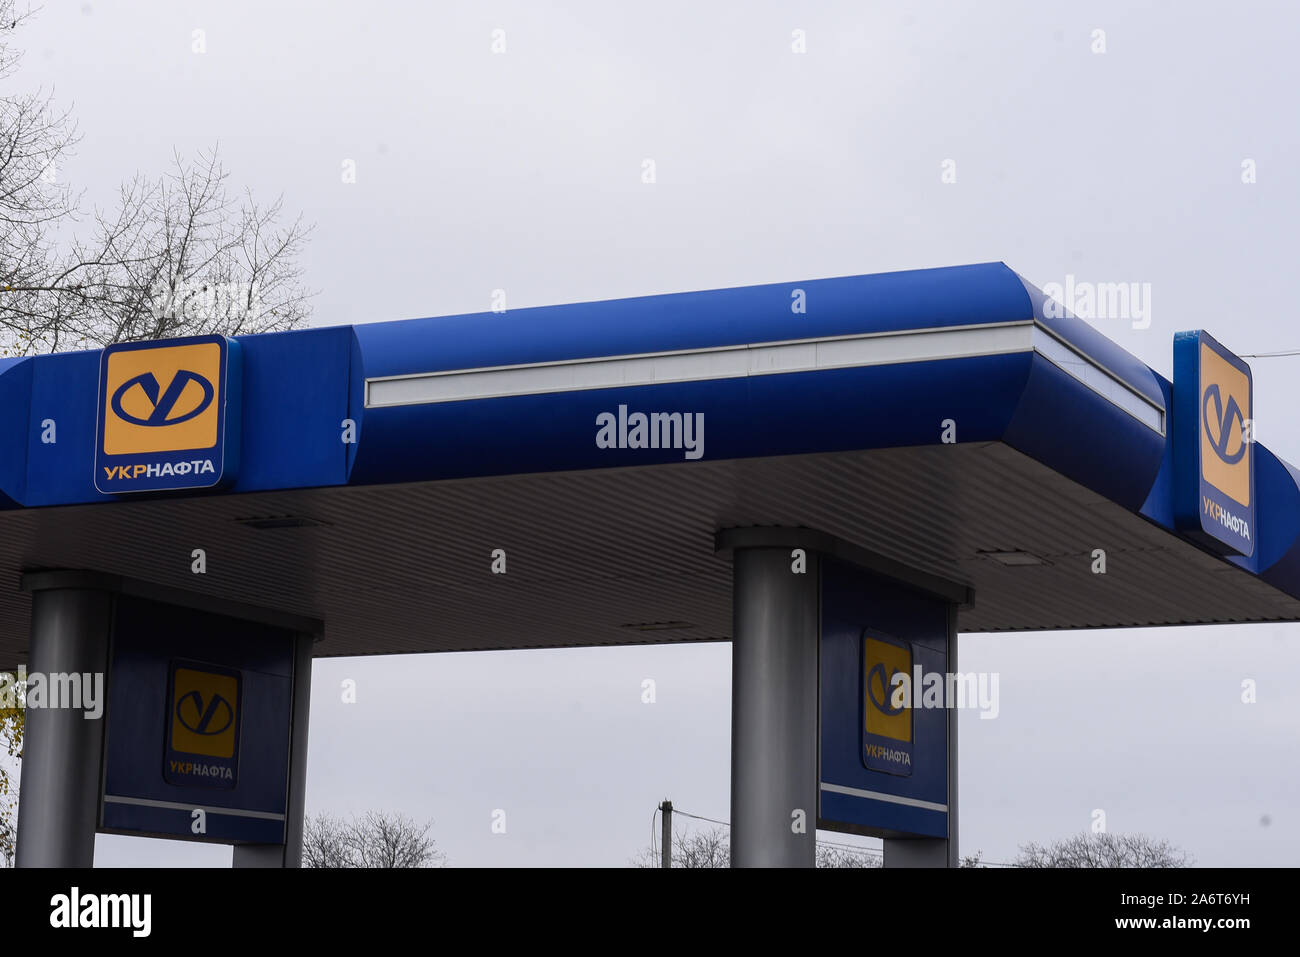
[[95, 335, 242, 493]]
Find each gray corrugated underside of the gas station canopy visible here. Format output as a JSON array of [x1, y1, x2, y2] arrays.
[[0, 443, 1300, 667]]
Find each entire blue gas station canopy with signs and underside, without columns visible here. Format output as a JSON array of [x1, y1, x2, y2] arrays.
[[0, 263, 1300, 668]]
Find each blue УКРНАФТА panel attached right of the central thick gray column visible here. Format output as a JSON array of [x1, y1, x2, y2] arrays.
[[818, 558, 948, 837]]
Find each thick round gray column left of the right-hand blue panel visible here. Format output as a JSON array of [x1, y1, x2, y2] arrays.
[[731, 547, 820, 867]]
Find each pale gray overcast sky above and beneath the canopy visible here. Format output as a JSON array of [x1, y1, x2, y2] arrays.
[[10, 0, 1300, 866]]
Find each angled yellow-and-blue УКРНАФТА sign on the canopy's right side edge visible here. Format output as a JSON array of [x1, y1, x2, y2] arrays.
[[1173, 332, 1256, 558]]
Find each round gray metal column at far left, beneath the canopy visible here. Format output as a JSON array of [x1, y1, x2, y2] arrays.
[[16, 588, 112, 867]]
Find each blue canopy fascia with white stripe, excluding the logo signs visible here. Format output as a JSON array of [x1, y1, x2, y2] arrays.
[[0, 263, 1300, 598]]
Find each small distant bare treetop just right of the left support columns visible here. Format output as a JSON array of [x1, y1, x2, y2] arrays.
[[303, 811, 446, 867]]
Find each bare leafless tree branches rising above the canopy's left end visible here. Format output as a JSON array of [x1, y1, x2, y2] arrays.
[[0, 0, 312, 355]]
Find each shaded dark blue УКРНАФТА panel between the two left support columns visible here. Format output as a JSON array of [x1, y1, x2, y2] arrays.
[[100, 596, 295, 844]]
